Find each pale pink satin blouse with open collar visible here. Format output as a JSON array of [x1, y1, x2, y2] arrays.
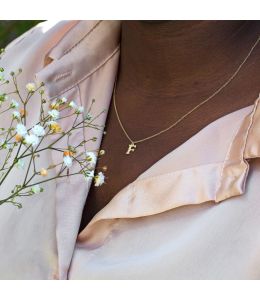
[[0, 21, 260, 279]]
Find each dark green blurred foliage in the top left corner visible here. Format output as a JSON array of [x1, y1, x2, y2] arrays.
[[0, 20, 42, 48]]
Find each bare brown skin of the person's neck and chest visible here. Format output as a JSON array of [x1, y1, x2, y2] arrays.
[[80, 21, 260, 230]]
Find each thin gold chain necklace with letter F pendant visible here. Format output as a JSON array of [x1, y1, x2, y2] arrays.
[[113, 36, 260, 155]]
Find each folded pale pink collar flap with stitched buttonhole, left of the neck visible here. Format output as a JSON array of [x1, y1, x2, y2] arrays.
[[36, 21, 120, 98]]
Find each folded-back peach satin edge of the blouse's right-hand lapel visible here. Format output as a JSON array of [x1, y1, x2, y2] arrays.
[[78, 97, 260, 248]]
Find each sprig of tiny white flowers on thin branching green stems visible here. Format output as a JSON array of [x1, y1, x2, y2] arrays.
[[0, 55, 105, 208]]
